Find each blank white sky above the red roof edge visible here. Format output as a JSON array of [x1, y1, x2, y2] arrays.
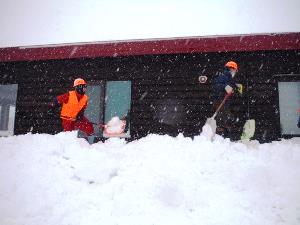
[[0, 0, 300, 47]]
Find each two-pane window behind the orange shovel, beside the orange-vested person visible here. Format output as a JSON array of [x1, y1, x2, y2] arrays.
[[85, 81, 131, 137]]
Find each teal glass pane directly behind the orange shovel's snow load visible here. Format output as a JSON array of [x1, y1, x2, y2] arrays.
[[105, 81, 131, 134]]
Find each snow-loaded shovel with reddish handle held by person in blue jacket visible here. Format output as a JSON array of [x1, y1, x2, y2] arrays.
[[201, 94, 230, 140]]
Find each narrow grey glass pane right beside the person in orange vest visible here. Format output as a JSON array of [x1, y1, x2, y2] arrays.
[[84, 84, 104, 136]]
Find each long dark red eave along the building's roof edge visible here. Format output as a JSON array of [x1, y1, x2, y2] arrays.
[[0, 33, 300, 62]]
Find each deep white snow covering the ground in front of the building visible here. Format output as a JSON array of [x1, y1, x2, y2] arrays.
[[0, 132, 300, 225]]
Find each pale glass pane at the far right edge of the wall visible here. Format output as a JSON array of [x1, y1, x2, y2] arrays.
[[278, 82, 300, 135]]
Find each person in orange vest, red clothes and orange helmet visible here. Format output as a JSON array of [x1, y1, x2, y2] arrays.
[[55, 78, 94, 136]]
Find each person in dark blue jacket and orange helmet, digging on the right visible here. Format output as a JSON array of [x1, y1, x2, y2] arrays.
[[213, 61, 243, 138]]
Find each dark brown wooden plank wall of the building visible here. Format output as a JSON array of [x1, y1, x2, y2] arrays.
[[0, 50, 300, 140]]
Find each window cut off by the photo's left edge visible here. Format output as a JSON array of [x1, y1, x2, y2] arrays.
[[0, 84, 18, 136]]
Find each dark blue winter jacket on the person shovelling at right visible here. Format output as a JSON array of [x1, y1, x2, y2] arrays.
[[213, 68, 236, 101]]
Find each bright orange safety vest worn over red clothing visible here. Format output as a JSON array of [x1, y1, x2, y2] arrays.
[[60, 91, 88, 121]]
